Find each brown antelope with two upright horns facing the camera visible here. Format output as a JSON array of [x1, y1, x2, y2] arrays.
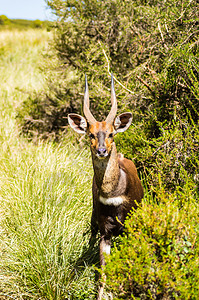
[[68, 76, 143, 299]]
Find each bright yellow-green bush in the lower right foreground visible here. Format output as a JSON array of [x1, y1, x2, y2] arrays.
[[105, 188, 199, 300]]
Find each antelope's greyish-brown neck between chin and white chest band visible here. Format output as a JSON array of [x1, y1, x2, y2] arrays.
[[92, 143, 120, 198]]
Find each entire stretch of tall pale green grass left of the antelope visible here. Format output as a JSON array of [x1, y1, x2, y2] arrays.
[[0, 30, 97, 299]]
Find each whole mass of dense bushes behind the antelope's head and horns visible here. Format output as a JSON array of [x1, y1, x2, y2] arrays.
[[18, 0, 199, 189]]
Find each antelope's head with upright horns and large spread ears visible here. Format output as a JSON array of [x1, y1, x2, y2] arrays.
[[68, 76, 132, 159]]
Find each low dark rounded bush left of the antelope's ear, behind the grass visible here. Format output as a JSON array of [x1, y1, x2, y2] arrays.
[[17, 69, 80, 140]]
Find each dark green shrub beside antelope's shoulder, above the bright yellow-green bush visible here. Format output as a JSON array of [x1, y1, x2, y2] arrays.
[[116, 118, 199, 191]]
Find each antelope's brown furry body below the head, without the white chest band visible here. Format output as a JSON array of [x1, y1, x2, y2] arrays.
[[91, 143, 143, 265]]
